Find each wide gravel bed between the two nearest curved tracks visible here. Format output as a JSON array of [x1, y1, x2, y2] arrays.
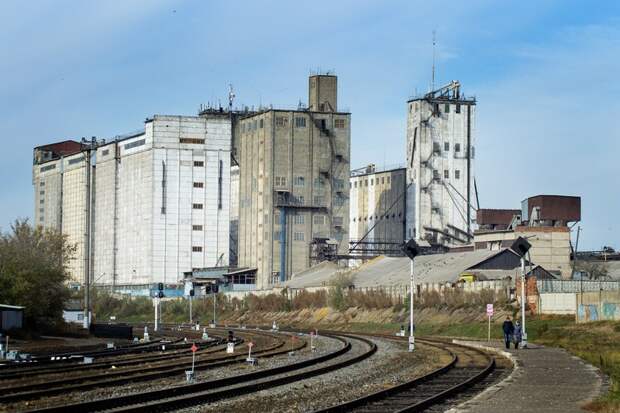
[[180, 339, 444, 413]]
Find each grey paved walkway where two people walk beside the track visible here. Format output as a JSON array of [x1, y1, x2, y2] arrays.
[[450, 343, 607, 413]]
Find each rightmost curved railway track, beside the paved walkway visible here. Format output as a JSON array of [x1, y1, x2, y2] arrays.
[[315, 335, 496, 413]]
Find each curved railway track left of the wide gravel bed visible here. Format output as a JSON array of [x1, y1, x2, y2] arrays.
[[13, 334, 377, 413]]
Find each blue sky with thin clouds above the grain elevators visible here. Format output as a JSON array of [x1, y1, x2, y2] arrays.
[[0, 0, 620, 249]]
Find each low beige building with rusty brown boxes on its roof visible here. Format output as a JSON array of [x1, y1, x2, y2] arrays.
[[474, 195, 581, 278]]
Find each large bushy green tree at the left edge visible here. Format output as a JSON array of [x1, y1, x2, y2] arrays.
[[0, 219, 76, 328]]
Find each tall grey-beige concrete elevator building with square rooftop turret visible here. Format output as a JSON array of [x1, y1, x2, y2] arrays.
[[234, 75, 351, 288]]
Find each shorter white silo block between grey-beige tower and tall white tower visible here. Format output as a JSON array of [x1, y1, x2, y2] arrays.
[[349, 164, 407, 255]]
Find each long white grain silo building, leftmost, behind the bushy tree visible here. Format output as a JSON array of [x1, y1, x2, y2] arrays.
[[33, 115, 231, 290]]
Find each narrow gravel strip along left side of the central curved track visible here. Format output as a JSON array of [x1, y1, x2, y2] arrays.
[[0, 332, 314, 412]]
